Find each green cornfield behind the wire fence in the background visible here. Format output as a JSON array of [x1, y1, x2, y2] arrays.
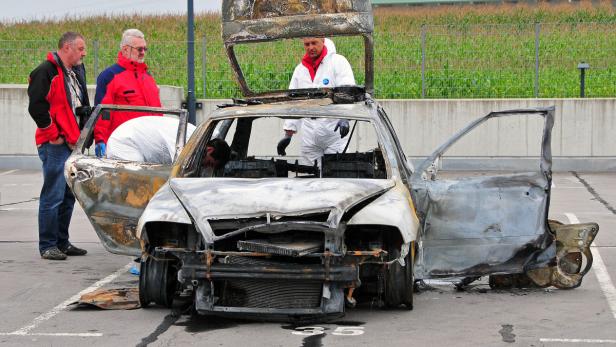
[[0, 2, 616, 98]]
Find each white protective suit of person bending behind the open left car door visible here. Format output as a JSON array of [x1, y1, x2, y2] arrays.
[[107, 116, 195, 164]]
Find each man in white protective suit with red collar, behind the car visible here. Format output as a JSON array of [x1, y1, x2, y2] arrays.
[[277, 37, 355, 166]]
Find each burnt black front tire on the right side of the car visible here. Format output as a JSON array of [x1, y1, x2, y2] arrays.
[[385, 249, 415, 310]]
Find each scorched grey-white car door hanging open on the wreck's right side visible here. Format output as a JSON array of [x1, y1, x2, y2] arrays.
[[411, 107, 554, 278]]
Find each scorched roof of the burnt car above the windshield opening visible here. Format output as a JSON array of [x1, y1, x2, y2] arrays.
[[210, 98, 373, 121]]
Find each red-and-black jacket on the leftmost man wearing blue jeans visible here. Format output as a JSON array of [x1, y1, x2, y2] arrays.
[[28, 52, 90, 145]]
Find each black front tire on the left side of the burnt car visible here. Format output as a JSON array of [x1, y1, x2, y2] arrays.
[[139, 257, 177, 307]]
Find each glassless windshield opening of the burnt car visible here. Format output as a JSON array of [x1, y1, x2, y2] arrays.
[[197, 116, 387, 179]]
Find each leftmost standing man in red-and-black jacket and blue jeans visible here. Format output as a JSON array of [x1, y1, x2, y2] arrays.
[[28, 32, 90, 260]]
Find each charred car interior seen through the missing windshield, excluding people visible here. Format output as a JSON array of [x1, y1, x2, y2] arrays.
[[193, 117, 387, 179]]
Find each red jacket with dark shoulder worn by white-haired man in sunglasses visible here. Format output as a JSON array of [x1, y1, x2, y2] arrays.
[[94, 52, 162, 143]]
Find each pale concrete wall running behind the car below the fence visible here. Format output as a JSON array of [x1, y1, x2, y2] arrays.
[[0, 85, 616, 171]]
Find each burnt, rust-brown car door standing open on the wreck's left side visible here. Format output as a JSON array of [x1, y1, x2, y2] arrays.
[[65, 105, 187, 256]]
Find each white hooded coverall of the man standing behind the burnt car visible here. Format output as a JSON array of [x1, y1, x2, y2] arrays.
[[283, 39, 355, 166]]
